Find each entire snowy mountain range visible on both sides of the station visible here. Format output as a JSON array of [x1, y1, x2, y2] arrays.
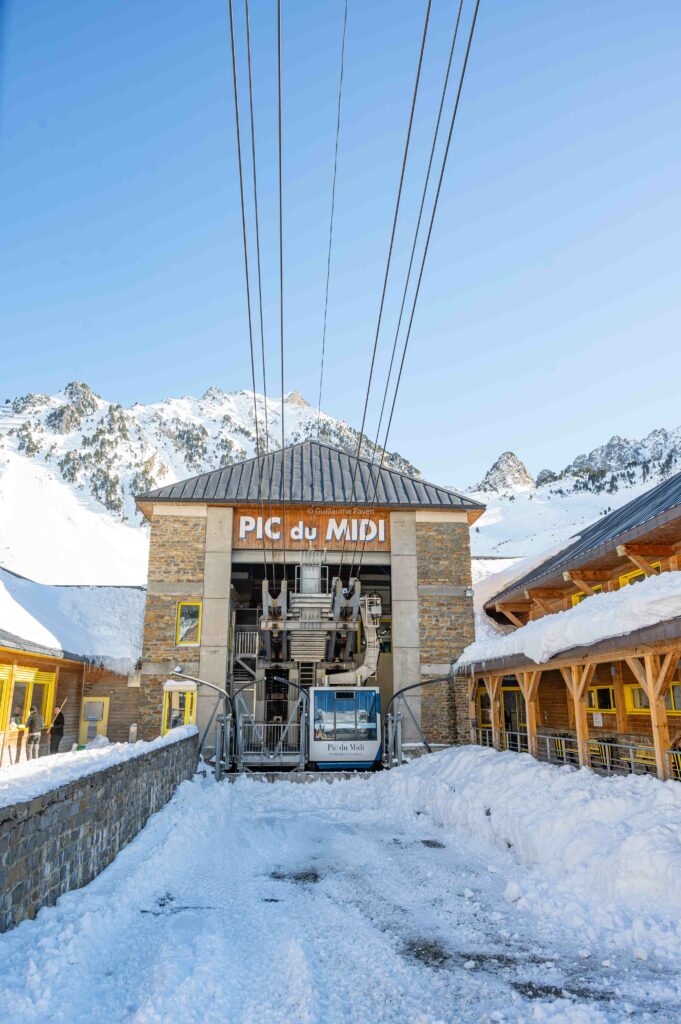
[[0, 383, 681, 585]]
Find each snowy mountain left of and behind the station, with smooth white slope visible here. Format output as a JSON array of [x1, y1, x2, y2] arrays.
[[0, 382, 413, 584]]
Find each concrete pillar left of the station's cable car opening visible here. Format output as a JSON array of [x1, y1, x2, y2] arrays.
[[197, 506, 233, 746]]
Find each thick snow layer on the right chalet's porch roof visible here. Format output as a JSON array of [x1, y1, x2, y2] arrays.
[[455, 572, 681, 669]]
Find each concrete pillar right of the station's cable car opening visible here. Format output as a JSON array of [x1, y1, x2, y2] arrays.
[[390, 512, 421, 742]]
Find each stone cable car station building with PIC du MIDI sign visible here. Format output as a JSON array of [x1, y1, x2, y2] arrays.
[[137, 441, 484, 743]]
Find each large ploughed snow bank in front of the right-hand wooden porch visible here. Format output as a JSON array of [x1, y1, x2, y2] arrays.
[[386, 746, 681, 956]]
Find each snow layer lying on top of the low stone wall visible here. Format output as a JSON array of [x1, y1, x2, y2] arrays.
[[0, 725, 198, 808]]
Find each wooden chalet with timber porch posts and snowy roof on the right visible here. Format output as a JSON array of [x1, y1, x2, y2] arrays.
[[456, 474, 681, 779]]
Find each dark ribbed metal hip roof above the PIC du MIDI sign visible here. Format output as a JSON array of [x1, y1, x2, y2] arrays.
[[136, 441, 485, 513]]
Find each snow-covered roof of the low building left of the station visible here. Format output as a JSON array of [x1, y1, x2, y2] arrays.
[[0, 568, 144, 673]]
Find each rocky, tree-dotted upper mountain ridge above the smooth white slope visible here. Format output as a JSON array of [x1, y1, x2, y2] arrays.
[[0, 381, 420, 521]]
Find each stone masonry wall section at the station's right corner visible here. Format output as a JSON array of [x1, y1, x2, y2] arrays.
[[416, 521, 475, 743]]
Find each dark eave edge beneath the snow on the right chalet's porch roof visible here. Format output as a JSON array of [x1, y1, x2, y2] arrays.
[[456, 615, 681, 676]]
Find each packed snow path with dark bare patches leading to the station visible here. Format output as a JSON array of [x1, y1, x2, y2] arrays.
[[0, 766, 680, 1024]]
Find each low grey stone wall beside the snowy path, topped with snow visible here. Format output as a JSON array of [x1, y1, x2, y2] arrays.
[[0, 735, 199, 932]]
